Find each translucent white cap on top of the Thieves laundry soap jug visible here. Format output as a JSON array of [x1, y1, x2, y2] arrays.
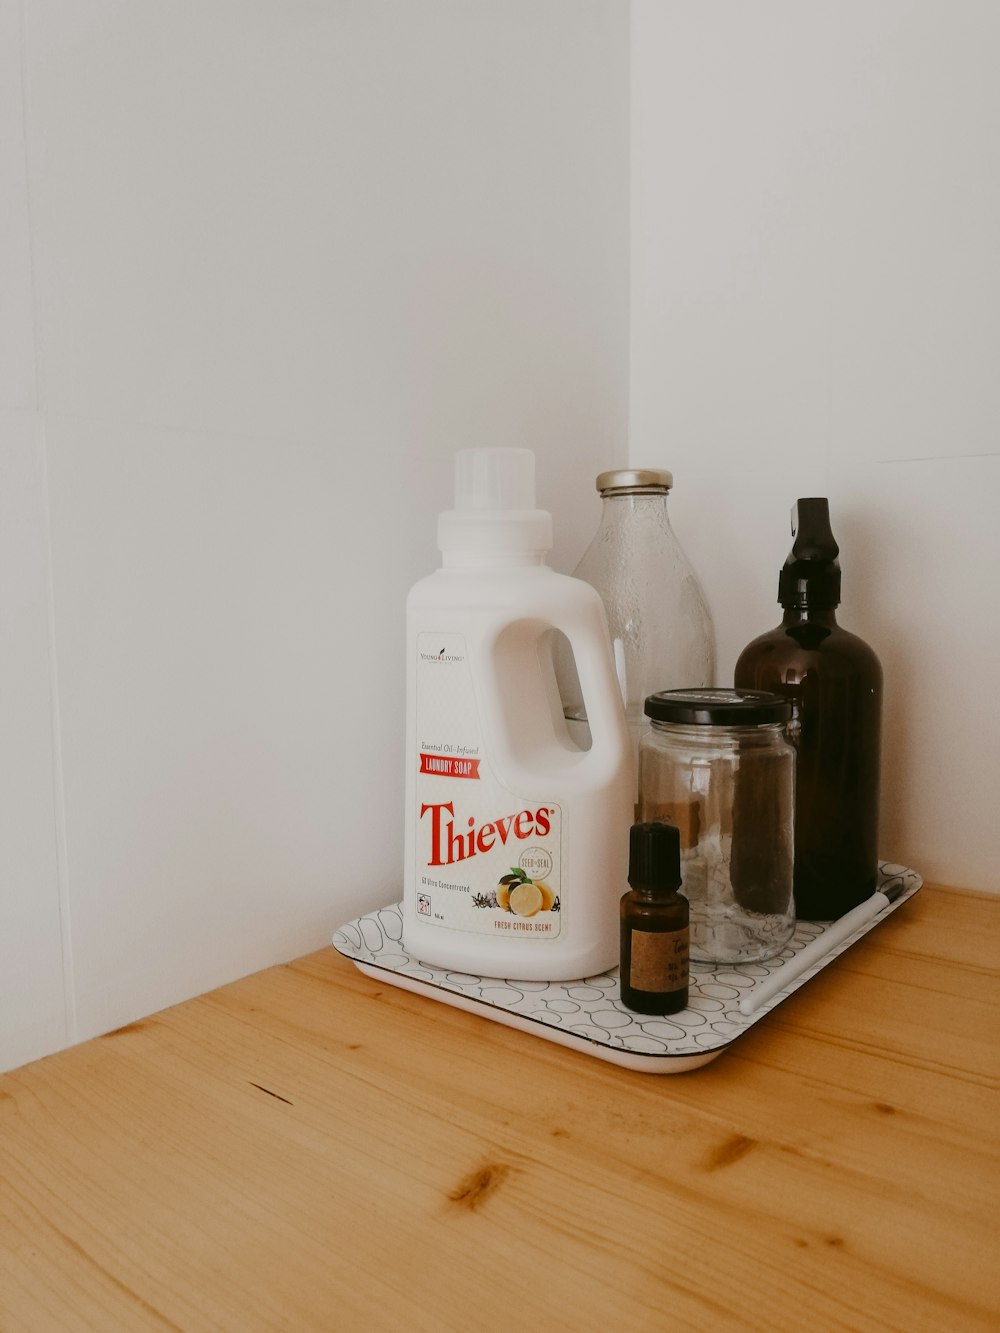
[[437, 449, 552, 553]]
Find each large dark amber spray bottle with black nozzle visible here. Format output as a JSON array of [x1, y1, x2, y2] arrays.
[[735, 499, 881, 921]]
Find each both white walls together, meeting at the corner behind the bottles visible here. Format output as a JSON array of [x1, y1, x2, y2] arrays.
[[0, 0, 1000, 1068]]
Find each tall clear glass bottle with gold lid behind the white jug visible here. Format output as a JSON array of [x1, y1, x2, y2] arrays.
[[559, 468, 715, 783]]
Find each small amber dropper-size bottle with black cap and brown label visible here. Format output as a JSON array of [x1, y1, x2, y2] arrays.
[[621, 822, 688, 1013]]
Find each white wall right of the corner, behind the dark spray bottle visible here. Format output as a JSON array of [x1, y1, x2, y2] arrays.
[[629, 0, 1000, 890]]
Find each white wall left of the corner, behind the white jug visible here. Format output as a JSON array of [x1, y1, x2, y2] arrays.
[[0, 0, 628, 1068]]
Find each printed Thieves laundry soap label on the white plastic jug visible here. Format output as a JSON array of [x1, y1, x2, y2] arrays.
[[413, 633, 561, 940]]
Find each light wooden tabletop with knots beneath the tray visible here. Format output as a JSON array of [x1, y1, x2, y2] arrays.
[[0, 886, 1000, 1333]]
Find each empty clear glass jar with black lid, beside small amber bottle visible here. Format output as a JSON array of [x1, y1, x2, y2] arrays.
[[639, 689, 795, 964]]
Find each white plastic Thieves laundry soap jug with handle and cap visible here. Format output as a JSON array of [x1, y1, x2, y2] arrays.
[[403, 449, 633, 981]]
